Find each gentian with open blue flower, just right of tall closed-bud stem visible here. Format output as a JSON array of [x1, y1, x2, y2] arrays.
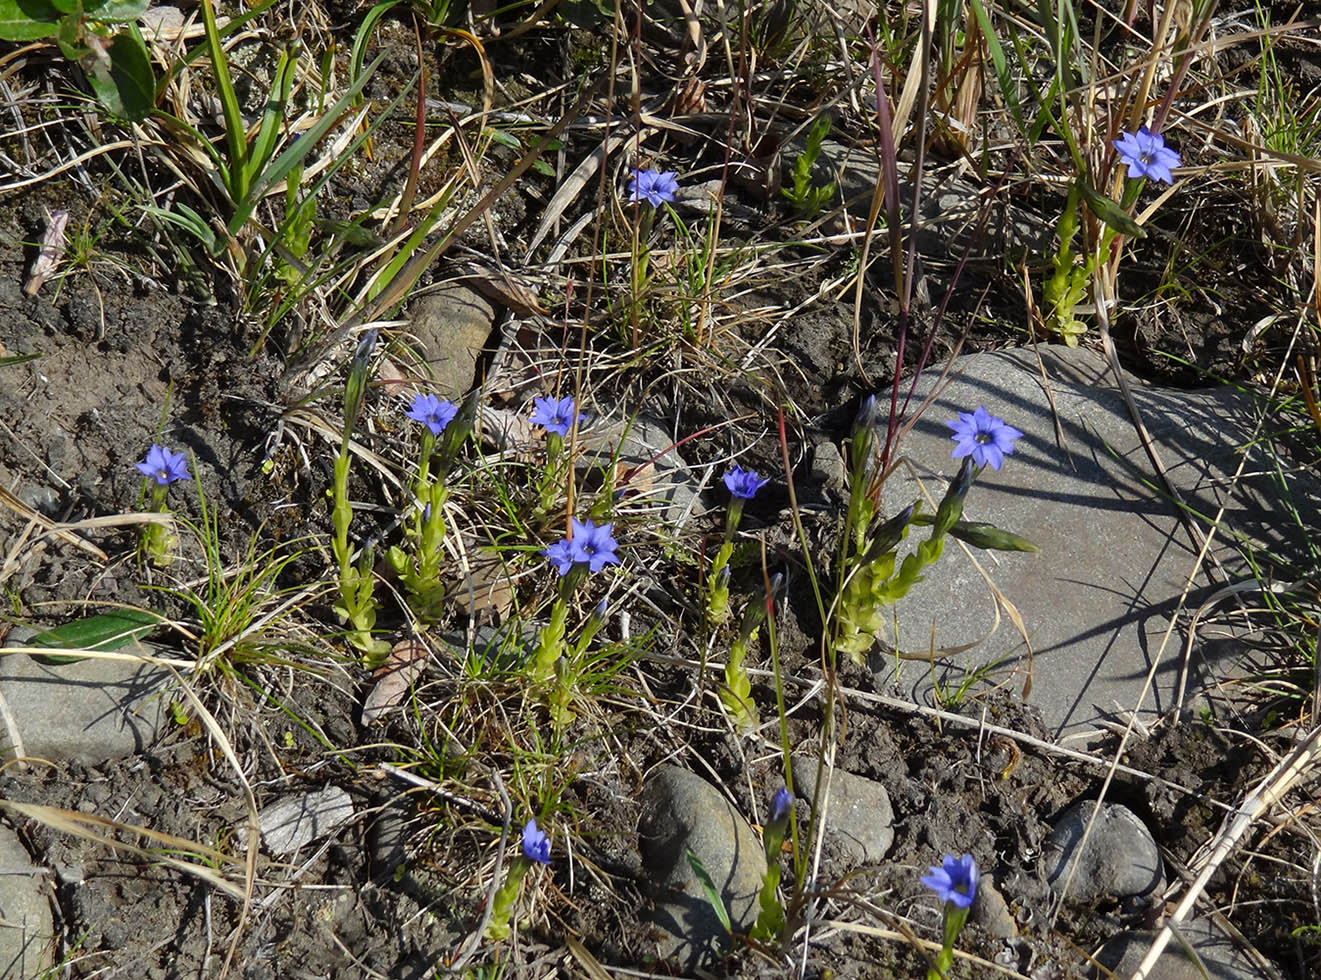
[[386, 395, 465, 621]]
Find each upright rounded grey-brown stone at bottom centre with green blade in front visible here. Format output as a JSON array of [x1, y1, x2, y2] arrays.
[[638, 766, 766, 969]]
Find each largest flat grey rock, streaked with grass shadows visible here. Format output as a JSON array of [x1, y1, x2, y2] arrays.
[[872, 345, 1321, 736]]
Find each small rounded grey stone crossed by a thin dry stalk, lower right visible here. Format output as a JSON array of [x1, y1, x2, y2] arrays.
[[1042, 800, 1164, 902]]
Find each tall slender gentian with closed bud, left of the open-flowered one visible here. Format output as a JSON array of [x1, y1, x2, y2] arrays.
[[330, 330, 390, 667]]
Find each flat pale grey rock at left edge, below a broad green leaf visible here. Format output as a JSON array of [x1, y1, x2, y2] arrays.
[[0, 630, 172, 766]]
